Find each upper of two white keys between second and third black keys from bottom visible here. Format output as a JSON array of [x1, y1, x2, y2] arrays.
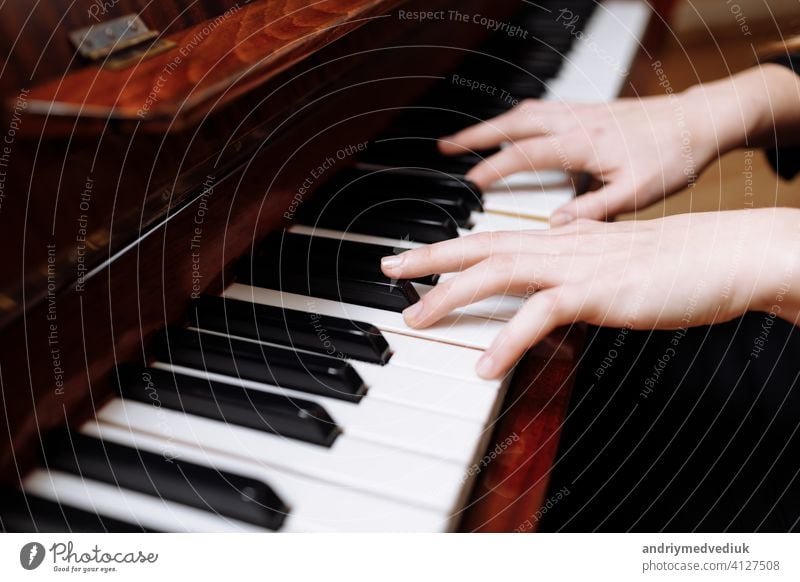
[[97, 399, 465, 513]]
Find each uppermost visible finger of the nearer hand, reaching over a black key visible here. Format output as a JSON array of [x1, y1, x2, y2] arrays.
[[381, 232, 533, 279]]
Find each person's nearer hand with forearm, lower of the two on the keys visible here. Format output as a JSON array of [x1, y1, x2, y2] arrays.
[[382, 209, 800, 378]]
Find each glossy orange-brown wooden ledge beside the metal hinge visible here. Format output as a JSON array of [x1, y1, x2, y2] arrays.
[[20, 0, 398, 131]]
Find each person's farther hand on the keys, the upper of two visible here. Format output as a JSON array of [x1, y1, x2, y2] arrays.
[[440, 65, 800, 226]]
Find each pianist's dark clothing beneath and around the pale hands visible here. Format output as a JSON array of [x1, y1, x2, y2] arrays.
[[540, 55, 800, 532]]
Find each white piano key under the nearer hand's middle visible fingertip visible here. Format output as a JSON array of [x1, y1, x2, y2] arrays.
[[223, 283, 505, 350]]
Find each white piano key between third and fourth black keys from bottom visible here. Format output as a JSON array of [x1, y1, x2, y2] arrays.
[[152, 362, 484, 465]]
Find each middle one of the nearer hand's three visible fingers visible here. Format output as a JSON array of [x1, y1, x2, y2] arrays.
[[403, 253, 560, 327]]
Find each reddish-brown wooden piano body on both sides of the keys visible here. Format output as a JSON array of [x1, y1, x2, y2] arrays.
[[0, 0, 652, 531]]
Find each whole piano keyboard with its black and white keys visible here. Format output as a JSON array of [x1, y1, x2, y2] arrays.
[[0, 0, 649, 532]]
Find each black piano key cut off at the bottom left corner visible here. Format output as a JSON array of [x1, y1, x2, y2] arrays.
[[0, 488, 153, 533]]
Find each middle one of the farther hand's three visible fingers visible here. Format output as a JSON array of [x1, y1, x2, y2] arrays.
[[467, 137, 580, 188]]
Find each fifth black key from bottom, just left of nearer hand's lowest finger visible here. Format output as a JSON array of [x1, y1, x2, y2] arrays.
[[188, 295, 392, 365]]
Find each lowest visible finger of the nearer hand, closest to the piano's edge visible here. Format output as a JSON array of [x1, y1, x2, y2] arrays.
[[477, 287, 581, 379]]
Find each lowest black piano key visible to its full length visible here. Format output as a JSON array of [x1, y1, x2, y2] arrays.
[[44, 431, 288, 530]]
